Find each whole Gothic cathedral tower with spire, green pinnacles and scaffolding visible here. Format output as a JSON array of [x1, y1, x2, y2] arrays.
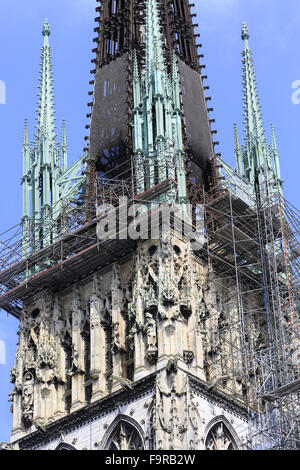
[[0, 0, 300, 450]]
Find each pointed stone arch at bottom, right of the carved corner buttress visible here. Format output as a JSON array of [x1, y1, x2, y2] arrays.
[[204, 415, 241, 450]]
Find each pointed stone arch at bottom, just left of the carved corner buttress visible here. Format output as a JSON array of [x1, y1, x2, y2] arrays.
[[100, 414, 145, 450]]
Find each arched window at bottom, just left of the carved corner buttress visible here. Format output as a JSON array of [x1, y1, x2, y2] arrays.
[[104, 419, 144, 450]]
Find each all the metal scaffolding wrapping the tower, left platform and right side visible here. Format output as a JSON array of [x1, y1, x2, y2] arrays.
[[0, 157, 300, 449]]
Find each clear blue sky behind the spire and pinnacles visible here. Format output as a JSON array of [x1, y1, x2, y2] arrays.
[[0, 0, 300, 441]]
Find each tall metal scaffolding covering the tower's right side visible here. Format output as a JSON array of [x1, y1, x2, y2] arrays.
[[197, 164, 300, 449]]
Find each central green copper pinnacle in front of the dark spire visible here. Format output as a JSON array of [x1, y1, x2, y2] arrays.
[[133, 0, 186, 202]]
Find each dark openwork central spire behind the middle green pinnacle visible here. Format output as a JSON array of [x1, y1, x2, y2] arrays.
[[85, 0, 218, 198]]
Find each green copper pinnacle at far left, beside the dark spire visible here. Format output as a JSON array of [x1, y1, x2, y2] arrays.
[[22, 18, 86, 257]]
